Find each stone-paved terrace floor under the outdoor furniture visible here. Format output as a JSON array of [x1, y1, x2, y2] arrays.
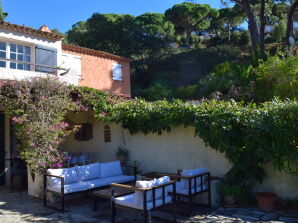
[[0, 187, 298, 223]]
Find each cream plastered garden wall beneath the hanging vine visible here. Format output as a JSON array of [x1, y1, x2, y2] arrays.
[[63, 113, 298, 199]]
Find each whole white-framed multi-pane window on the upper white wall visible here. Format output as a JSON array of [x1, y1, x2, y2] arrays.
[[0, 41, 31, 70]]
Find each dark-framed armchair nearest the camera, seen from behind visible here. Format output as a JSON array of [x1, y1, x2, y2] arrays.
[[111, 181, 176, 223]]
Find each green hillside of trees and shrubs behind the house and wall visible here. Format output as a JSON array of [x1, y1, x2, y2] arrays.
[[66, 0, 297, 102]]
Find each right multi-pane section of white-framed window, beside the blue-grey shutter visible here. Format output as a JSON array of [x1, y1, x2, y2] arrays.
[[9, 43, 31, 70]]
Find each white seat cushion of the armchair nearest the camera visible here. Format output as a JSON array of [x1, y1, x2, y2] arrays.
[[115, 194, 172, 210]]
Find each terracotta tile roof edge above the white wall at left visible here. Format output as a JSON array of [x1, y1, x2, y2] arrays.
[[0, 21, 64, 40]]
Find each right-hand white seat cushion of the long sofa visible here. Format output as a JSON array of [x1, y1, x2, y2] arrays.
[[85, 175, 134, 189]]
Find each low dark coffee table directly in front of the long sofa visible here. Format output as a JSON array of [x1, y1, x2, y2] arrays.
[[92, 184, 135, 211]]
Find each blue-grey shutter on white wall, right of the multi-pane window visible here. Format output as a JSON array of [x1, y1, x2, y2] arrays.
[[35, 45, 57, 73]]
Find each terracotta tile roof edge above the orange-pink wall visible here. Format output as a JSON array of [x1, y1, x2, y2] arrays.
[[62, 44, 131, 62]]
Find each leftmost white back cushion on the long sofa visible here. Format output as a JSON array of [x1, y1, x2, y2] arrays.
[[47, 167, 80, 187]]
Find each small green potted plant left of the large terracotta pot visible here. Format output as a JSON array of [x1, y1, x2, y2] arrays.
[[220, 183, 241, 207]]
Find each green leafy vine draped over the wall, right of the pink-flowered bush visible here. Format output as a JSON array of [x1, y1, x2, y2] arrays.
[[82, 96, 298, 184]]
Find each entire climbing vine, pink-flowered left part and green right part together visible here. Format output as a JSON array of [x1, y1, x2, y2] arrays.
[[0, 78, 298, 184]]
